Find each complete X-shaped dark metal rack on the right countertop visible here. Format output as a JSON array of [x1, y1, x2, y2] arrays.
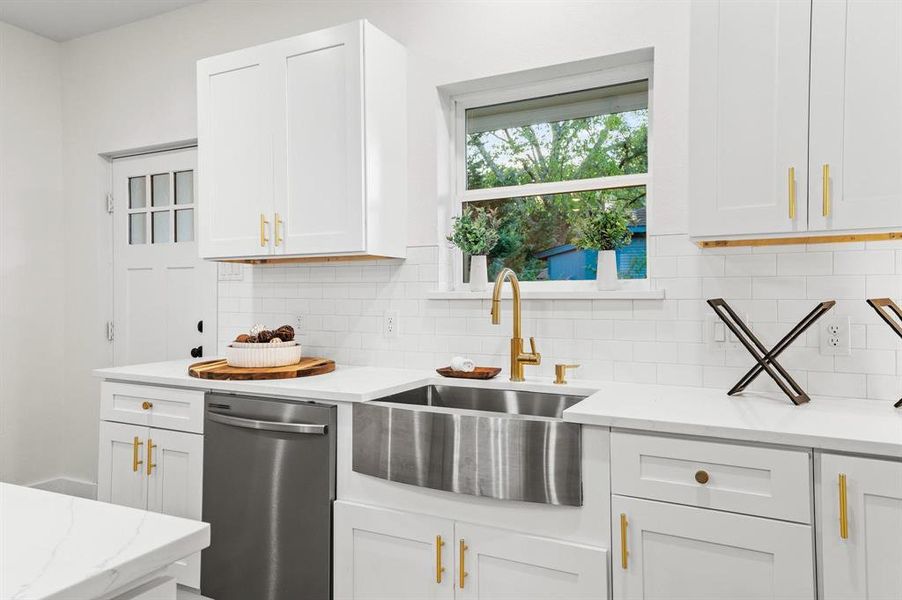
[[708, 298, 836, 405]]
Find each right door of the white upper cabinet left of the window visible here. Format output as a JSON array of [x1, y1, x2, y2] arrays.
[[273, 21, 368, 254]]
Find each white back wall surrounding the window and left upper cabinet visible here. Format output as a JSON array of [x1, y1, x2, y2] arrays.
[[56, 1, 688, 479]]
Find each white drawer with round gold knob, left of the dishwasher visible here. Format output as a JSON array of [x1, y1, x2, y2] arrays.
[[100, 381, 204, 433]]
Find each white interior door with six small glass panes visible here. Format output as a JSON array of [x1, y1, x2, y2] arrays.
[[113, 149, 217, 365]]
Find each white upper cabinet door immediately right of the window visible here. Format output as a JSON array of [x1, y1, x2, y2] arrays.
[[689, 0, 811, 236]]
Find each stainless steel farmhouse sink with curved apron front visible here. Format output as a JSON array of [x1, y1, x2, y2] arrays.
[[353, 385, 584, 506]]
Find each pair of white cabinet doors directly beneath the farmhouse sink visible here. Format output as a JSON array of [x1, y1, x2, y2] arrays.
[[334, 501, 608, 600]]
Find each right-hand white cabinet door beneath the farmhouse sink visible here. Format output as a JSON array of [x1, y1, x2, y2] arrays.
[[454, 522, 608, 600]]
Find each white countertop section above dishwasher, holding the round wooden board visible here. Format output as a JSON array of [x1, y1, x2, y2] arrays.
[[94, 359, 435, 402]]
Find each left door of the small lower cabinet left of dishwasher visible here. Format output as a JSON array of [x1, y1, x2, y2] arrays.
[[97, 421, 148, 509]]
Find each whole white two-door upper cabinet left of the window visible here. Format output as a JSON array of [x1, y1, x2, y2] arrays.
[[198, 21, 407, 259]]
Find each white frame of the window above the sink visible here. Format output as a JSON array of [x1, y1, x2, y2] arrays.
[[448, 60, 654, 290]]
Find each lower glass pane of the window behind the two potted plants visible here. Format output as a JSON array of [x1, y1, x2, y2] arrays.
[[463, 186, 646, 282]]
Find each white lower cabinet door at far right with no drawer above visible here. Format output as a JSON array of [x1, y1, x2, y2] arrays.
[[819, 454, 902, 600]]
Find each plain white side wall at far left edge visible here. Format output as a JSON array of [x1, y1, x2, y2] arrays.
[[0, 23, 65, 484]]
